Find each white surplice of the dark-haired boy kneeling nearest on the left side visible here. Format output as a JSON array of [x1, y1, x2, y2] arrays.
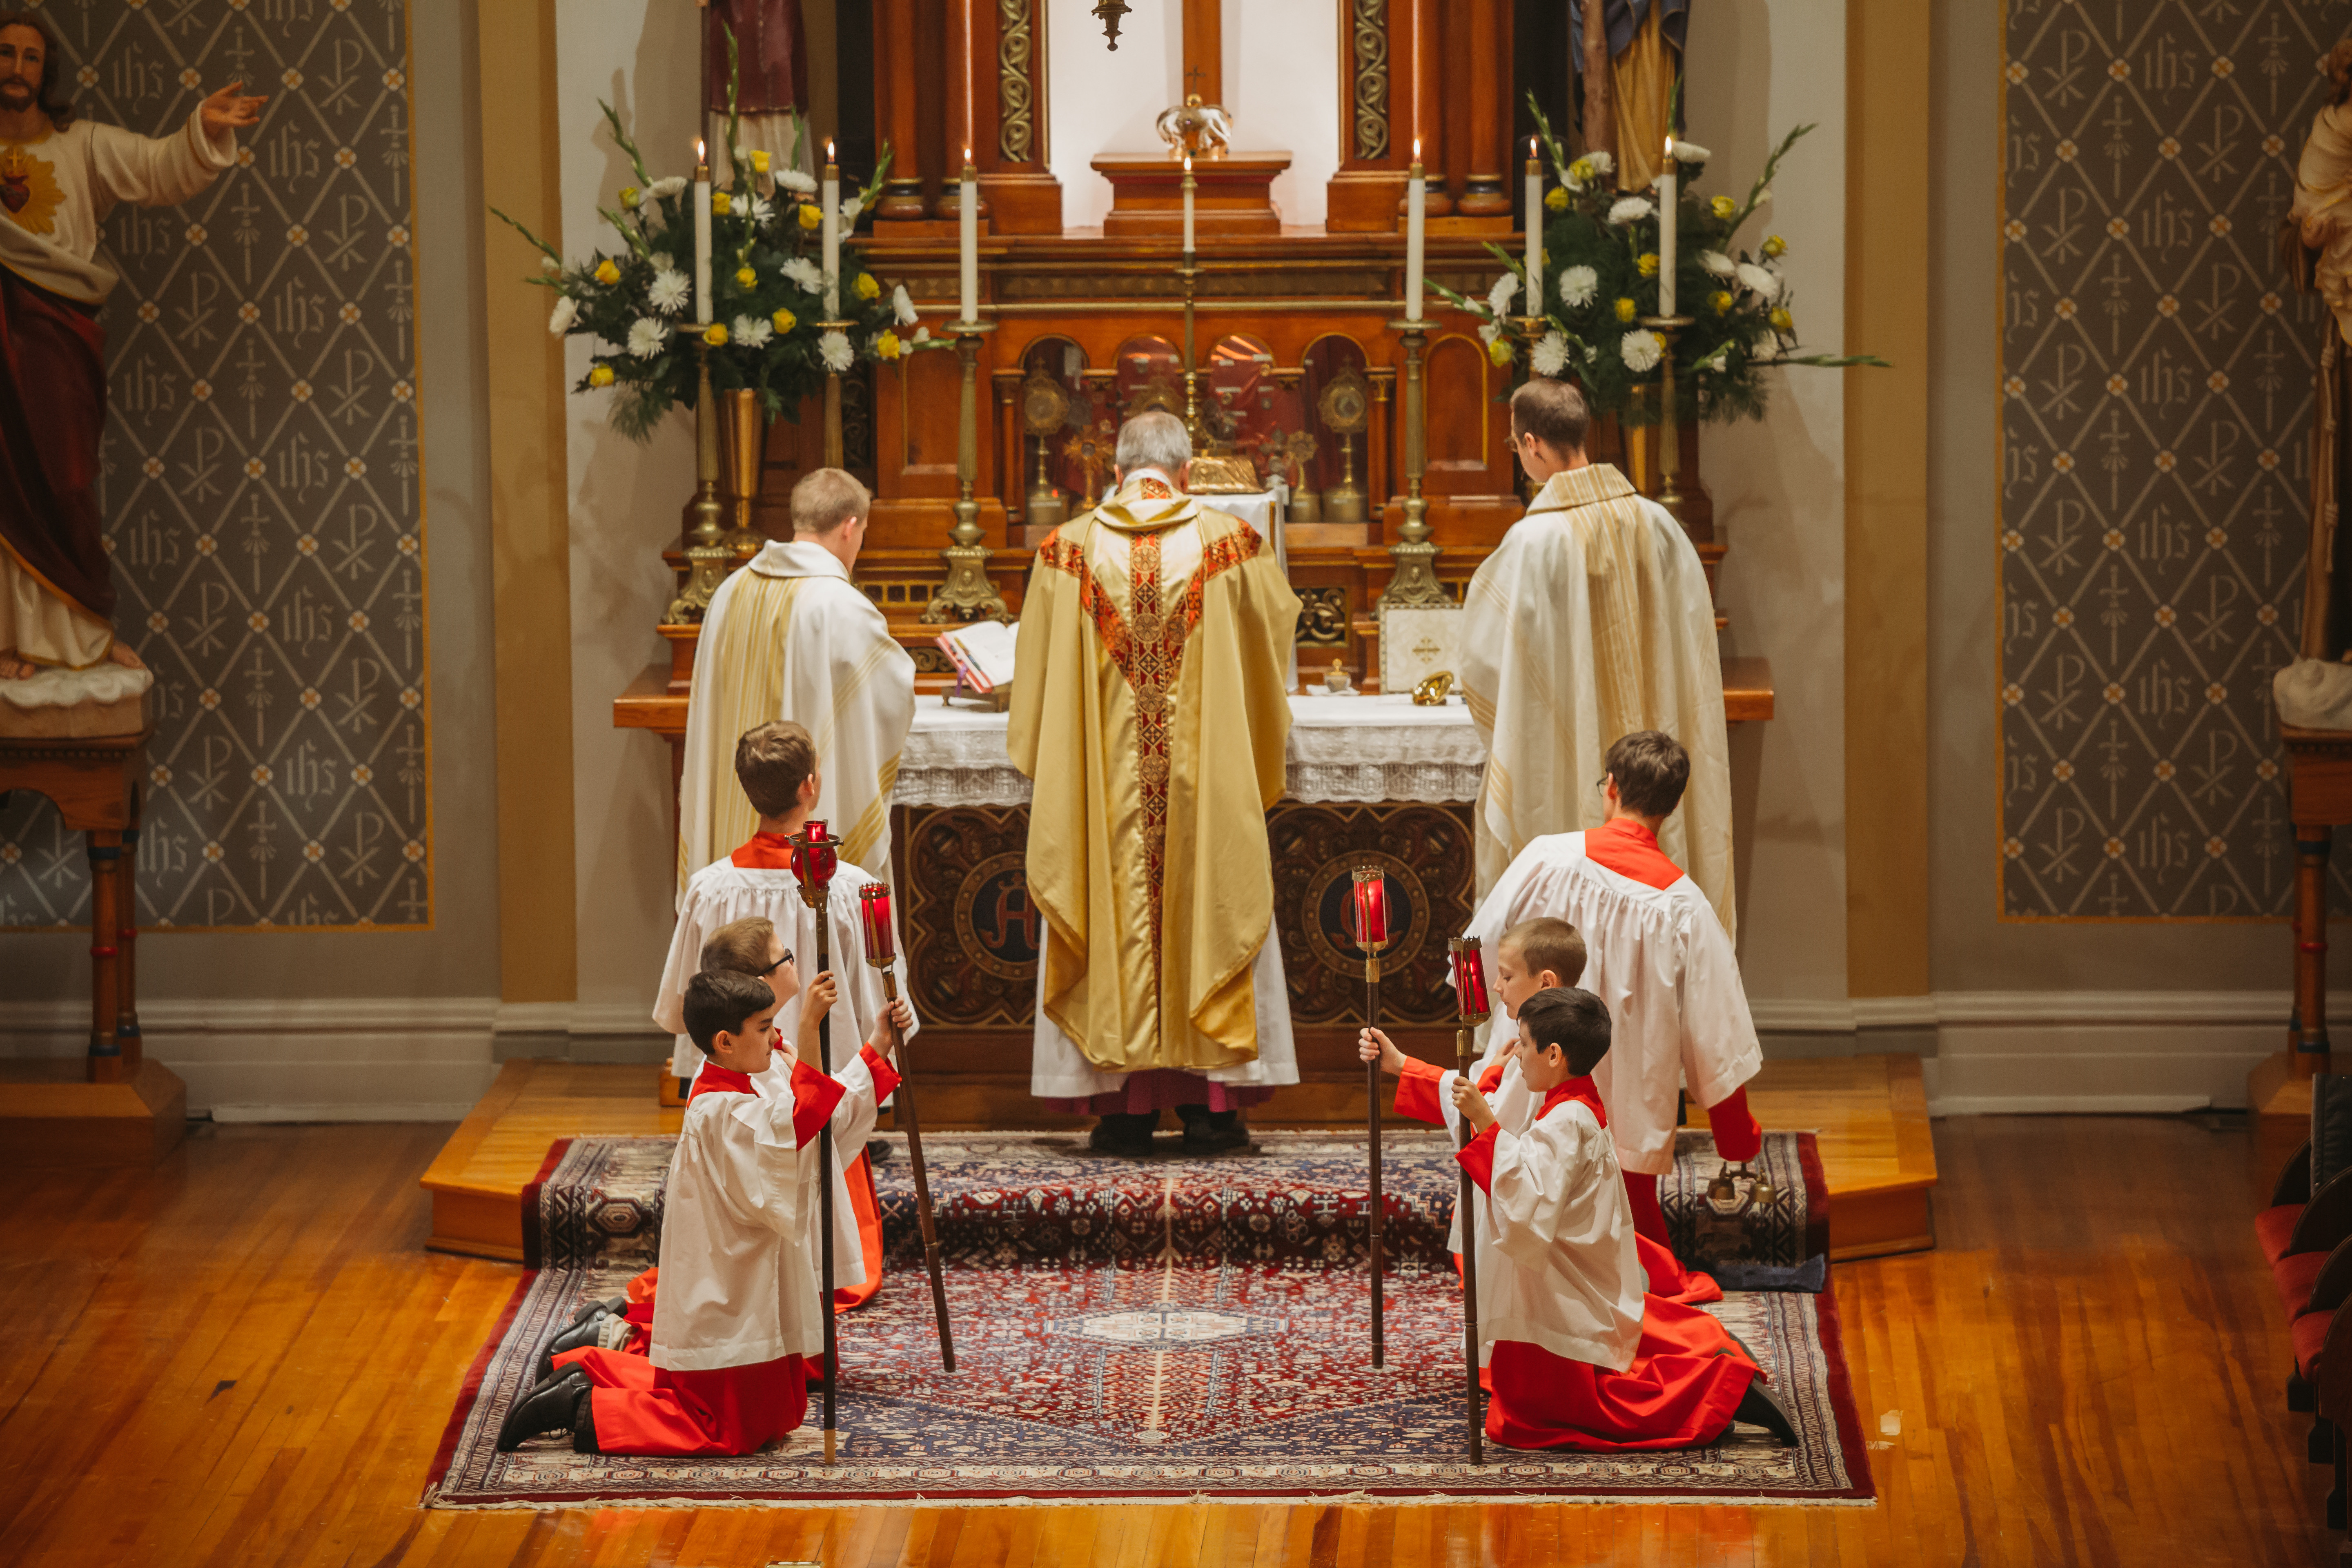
[[647, 1053, 875, 1370]]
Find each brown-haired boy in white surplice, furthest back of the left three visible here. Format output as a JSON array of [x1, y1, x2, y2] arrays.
[[654, 719, 927, 1310]]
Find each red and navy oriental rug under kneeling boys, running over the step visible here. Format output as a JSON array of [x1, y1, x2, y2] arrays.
[[426, 1133, 1875, 1507]]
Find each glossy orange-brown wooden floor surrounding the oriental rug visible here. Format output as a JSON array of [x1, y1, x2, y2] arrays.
[[0, 1117, 2336, 1568]]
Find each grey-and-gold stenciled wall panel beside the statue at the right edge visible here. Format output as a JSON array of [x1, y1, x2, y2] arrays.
[[2004, 0, 2352, 921]]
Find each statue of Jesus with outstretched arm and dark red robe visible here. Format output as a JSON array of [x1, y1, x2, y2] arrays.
[[0, 12, 263, 679]]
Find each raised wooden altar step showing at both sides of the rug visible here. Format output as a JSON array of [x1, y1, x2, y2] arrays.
[[423, 1056, 1936, 1263]]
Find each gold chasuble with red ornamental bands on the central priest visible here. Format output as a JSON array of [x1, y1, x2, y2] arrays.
[[1007, 470, 1298, 1072]]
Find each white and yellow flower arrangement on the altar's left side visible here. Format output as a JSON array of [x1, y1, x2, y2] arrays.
[[492, 78, 943, 442]]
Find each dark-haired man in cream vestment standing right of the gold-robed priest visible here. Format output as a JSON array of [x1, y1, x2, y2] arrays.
[[1456, 376, 1736, 938]]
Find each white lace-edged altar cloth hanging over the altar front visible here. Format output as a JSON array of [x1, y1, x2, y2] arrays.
[[891, 691, 1486, 806]]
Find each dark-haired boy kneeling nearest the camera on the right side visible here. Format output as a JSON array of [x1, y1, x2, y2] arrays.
[[1362, 987, 1797, 1450]]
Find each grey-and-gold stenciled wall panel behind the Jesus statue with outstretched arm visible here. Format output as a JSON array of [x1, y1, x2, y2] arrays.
[[0, 0, 433, 929]]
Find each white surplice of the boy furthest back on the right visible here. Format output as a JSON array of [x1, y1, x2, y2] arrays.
[[1470, 832, 1764, 1176]]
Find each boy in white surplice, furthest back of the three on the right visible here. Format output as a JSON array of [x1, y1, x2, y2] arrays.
[[1470, 729, 1764, 1300]]
